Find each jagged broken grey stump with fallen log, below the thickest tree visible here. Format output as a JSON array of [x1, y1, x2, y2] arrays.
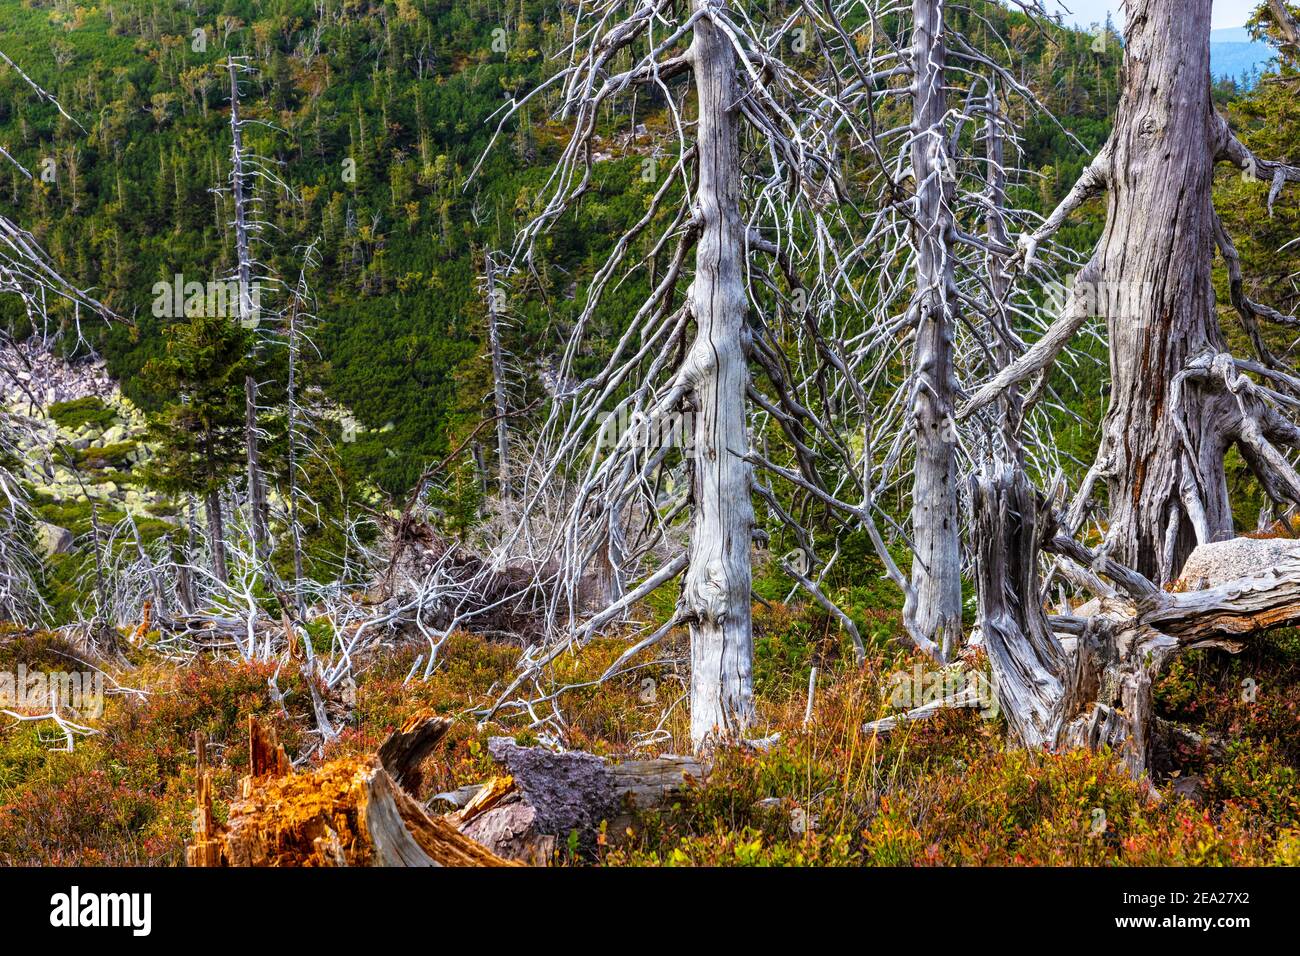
[[971, 466, 1300, 778]]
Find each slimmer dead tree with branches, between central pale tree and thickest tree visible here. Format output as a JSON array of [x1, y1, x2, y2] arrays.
[[848, 0, 1069, 661]]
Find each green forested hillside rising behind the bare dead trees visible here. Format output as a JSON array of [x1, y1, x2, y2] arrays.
[[0, 0, 1138, 496]]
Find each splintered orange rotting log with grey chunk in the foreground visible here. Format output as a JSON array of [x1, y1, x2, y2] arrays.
[[186, 710, 703, 866]]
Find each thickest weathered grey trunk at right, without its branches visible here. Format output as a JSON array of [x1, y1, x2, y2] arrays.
[[1093, 0, 1238, 581]]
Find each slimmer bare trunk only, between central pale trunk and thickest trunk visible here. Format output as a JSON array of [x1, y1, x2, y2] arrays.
[[909, 0, 962, 659]]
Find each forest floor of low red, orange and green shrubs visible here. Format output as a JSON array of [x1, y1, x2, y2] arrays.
[[0, 604, 1300, 866]]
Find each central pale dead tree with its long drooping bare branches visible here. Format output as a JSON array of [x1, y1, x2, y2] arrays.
[[473, 0, 897, 748]]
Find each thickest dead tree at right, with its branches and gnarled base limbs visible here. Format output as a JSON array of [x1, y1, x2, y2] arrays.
[[962, 0, 1300, 583]]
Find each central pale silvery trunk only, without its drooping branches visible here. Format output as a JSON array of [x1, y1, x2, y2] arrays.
[[681, 0, 754, 749]]
